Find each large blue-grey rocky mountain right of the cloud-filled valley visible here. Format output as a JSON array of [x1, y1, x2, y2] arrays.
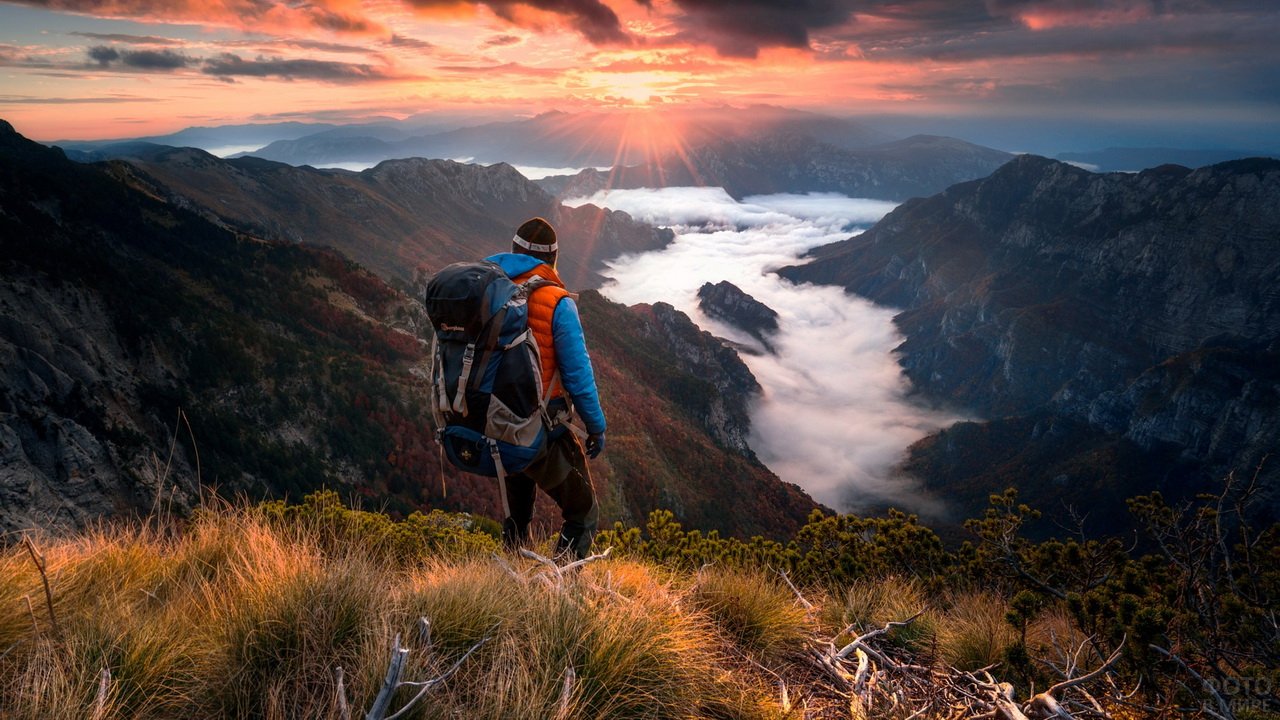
[[782, 156, 1280, 520]]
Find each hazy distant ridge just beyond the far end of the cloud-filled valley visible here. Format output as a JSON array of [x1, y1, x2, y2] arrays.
[[539, 133, 1012, 200]]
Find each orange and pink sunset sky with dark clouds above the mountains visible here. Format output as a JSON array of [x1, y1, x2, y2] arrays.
[[0, 0, 1280, 146]]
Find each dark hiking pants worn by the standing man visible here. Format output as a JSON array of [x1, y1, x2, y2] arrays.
[[502, 430, 600, 559]]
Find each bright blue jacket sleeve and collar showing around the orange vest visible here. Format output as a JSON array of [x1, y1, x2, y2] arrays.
[[485, 252, 605, 434]]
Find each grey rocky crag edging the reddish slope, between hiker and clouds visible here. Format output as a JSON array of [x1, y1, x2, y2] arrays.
[[629, 302, 760, 459]]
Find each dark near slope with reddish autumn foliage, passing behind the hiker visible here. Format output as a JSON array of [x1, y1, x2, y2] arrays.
[[0, 124, 813, 534]]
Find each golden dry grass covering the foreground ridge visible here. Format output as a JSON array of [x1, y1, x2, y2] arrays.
[[0, 507, 1100, 720]]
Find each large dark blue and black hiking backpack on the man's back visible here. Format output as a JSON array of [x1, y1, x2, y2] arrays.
[[425, 261, 552, 491]]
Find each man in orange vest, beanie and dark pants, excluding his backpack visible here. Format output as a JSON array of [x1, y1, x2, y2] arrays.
[[486, 218, 604, 557]]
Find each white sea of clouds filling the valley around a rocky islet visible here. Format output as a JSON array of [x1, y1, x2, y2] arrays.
[[568, 187, 957, 515]]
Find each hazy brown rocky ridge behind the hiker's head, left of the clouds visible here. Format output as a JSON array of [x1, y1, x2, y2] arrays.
[[113, 147, 673, 288]]
